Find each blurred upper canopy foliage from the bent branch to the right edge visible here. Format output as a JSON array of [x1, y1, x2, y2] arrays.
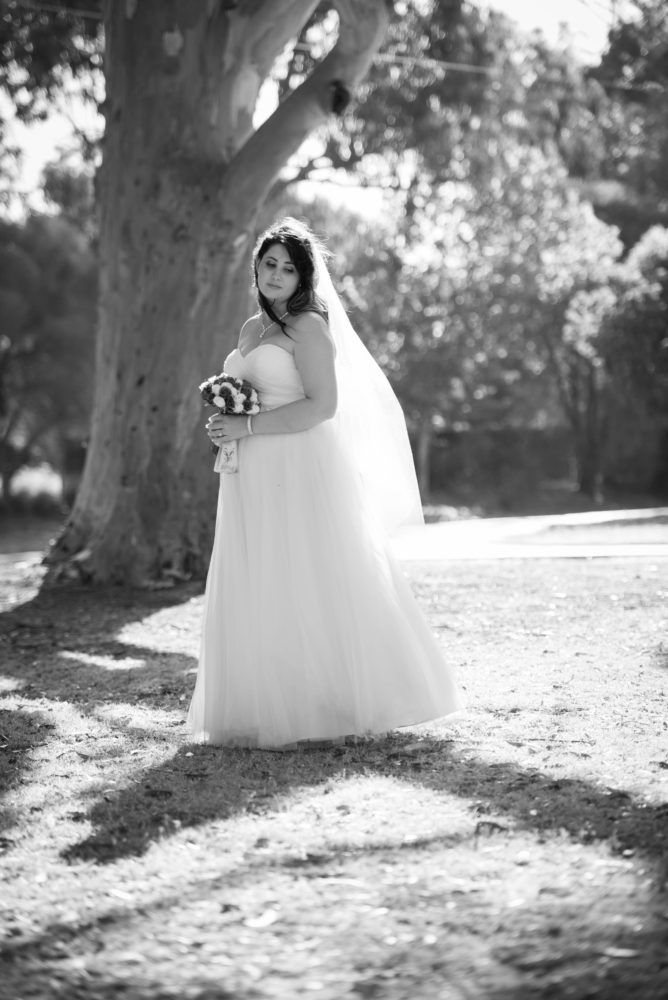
[[280, 0, 668, 248]]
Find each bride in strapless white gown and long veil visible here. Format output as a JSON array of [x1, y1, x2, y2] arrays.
[[188, 219, 460, 748]]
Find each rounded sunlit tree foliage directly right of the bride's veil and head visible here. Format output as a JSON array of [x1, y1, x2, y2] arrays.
[[282, 150, 621, 498]]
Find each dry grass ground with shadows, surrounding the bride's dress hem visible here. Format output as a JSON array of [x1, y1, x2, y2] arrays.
[[0, 548, 668, 1000]]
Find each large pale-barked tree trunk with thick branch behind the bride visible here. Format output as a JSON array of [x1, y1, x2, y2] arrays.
[[49, 0, 388, 583]]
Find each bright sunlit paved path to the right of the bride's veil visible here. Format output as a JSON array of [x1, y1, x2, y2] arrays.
[[393, 507, 668, 561]]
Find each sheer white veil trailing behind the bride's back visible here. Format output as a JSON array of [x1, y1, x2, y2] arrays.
[[315, 246, 424, 535]]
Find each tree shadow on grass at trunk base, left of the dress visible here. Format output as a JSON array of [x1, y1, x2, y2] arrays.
[[0, 584, 201, 836]]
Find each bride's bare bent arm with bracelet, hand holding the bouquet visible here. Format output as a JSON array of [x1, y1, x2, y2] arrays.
[[207, 313, 337, 444]]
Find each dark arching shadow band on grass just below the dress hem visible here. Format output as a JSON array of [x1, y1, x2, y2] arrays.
[[60, 732, 668, 863]]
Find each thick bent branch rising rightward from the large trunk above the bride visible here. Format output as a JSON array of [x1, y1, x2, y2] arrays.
[[221, 0, 389, 207]]
